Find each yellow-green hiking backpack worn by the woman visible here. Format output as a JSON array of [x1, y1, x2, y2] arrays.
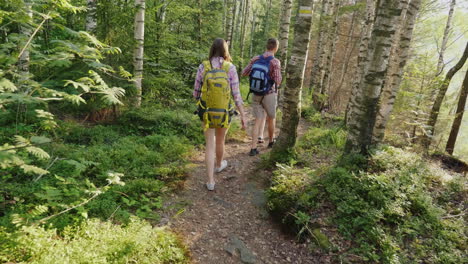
[[198, 61, 233, 129]]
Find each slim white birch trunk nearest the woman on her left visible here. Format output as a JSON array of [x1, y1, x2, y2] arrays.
[[133, 0, 145, 107]]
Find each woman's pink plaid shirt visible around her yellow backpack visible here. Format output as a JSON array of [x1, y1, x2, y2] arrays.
[[193, 57, 244, 106]]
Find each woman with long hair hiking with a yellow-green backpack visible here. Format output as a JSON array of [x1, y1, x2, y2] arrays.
[[193, 38, 246, 191]]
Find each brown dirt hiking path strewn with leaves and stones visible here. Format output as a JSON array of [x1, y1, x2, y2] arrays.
[[163, 110, 326, 264]]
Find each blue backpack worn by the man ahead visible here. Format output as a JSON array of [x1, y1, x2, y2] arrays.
[[247, 55, 274, 98]]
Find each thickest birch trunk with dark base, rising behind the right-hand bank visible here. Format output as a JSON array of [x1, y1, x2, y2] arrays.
[[346, 0, 406, 154]]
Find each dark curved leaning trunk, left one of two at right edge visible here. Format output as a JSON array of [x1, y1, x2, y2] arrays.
[[424, 42, 468, 148]]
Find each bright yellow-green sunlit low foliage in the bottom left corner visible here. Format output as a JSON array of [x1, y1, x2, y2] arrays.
[[0, 218, 189, 264]]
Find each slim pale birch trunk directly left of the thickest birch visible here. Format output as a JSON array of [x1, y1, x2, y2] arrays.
[[345, 0, 375, 124]]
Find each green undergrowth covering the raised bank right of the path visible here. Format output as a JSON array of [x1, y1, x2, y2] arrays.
[[267, 112, 467, 263]]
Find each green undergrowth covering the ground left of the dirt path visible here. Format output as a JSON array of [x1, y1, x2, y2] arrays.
[[0, 107, 195, 263]]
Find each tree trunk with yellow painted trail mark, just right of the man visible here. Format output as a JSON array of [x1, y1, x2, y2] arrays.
[[272, 0, 314, 159]]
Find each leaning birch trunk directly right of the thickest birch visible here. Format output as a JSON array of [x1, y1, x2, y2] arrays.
[[373, 0, 421, 143]]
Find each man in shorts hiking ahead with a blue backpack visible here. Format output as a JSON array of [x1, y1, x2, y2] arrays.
[[242, 38, 282, 156]]
